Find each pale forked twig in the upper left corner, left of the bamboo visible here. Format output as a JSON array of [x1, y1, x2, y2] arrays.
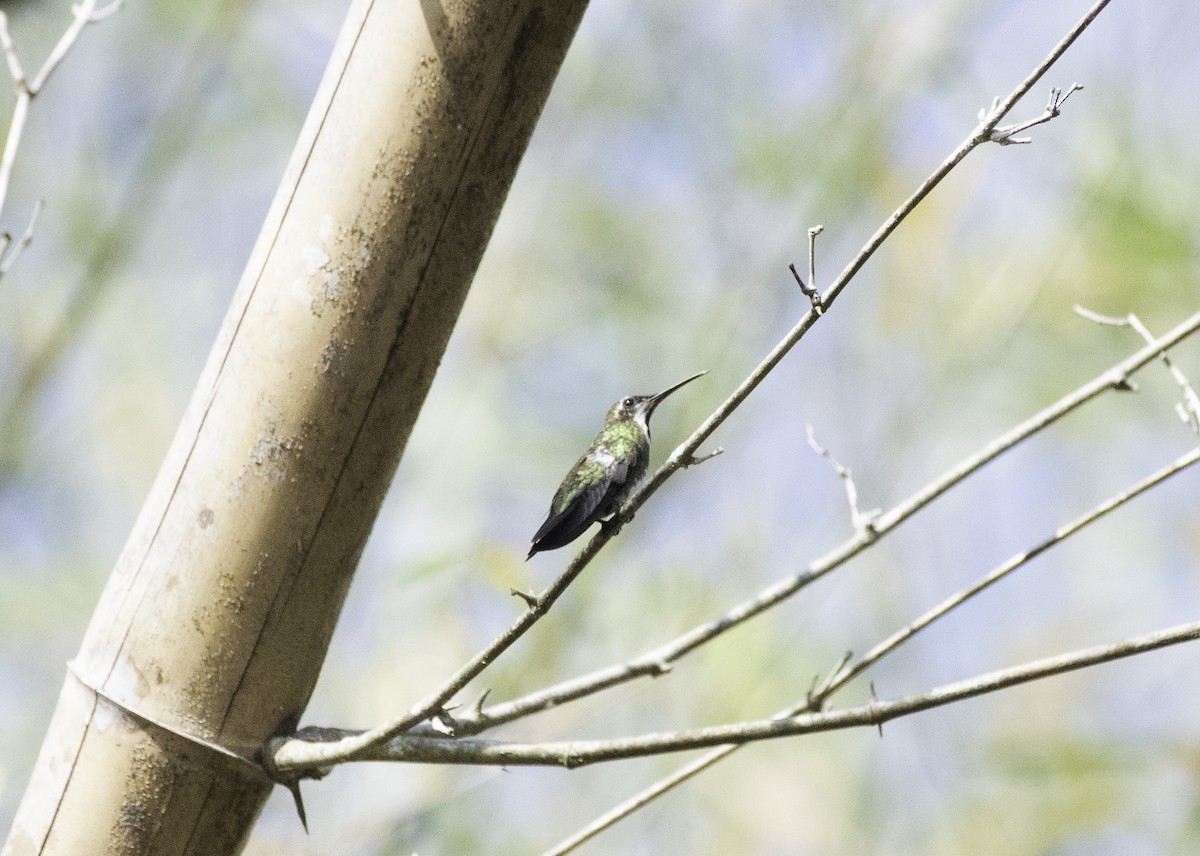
[[0, 0, 122, 276]]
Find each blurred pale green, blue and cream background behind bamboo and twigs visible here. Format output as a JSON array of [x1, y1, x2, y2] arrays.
[[0, 0, 1200, 856]]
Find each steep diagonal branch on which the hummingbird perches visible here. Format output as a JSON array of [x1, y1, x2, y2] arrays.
[[265, 0, 1109, 770]]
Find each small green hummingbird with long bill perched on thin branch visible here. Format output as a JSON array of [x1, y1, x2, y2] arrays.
[[526, 371, 708, 562]]
